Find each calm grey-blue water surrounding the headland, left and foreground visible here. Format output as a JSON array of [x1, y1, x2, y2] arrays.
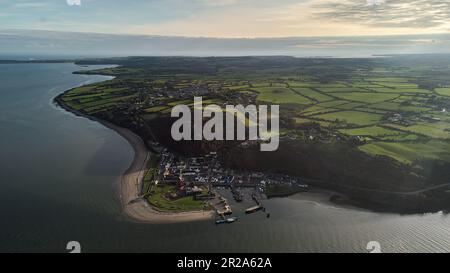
[[0, 64, 450, 252]]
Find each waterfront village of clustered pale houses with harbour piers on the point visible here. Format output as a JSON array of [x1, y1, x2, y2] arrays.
[[147, 149, 308, 224]]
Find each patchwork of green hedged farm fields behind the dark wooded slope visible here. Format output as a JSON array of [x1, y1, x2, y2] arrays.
[[63, 55, 450, 165]]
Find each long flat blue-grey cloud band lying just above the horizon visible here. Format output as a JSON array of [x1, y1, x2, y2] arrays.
[[0, 30, 450, 57]]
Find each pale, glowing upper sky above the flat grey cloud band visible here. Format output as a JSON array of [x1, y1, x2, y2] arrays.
[[0, 0, 450, 38]]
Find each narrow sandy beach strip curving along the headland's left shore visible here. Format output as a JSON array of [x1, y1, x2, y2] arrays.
[[54, 78, 214, 224]]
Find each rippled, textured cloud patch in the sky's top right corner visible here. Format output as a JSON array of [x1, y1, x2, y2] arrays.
[[315, 0, 450, 28]]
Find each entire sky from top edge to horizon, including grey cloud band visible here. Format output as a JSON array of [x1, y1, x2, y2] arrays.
[[0, 0, 450, 57]]
